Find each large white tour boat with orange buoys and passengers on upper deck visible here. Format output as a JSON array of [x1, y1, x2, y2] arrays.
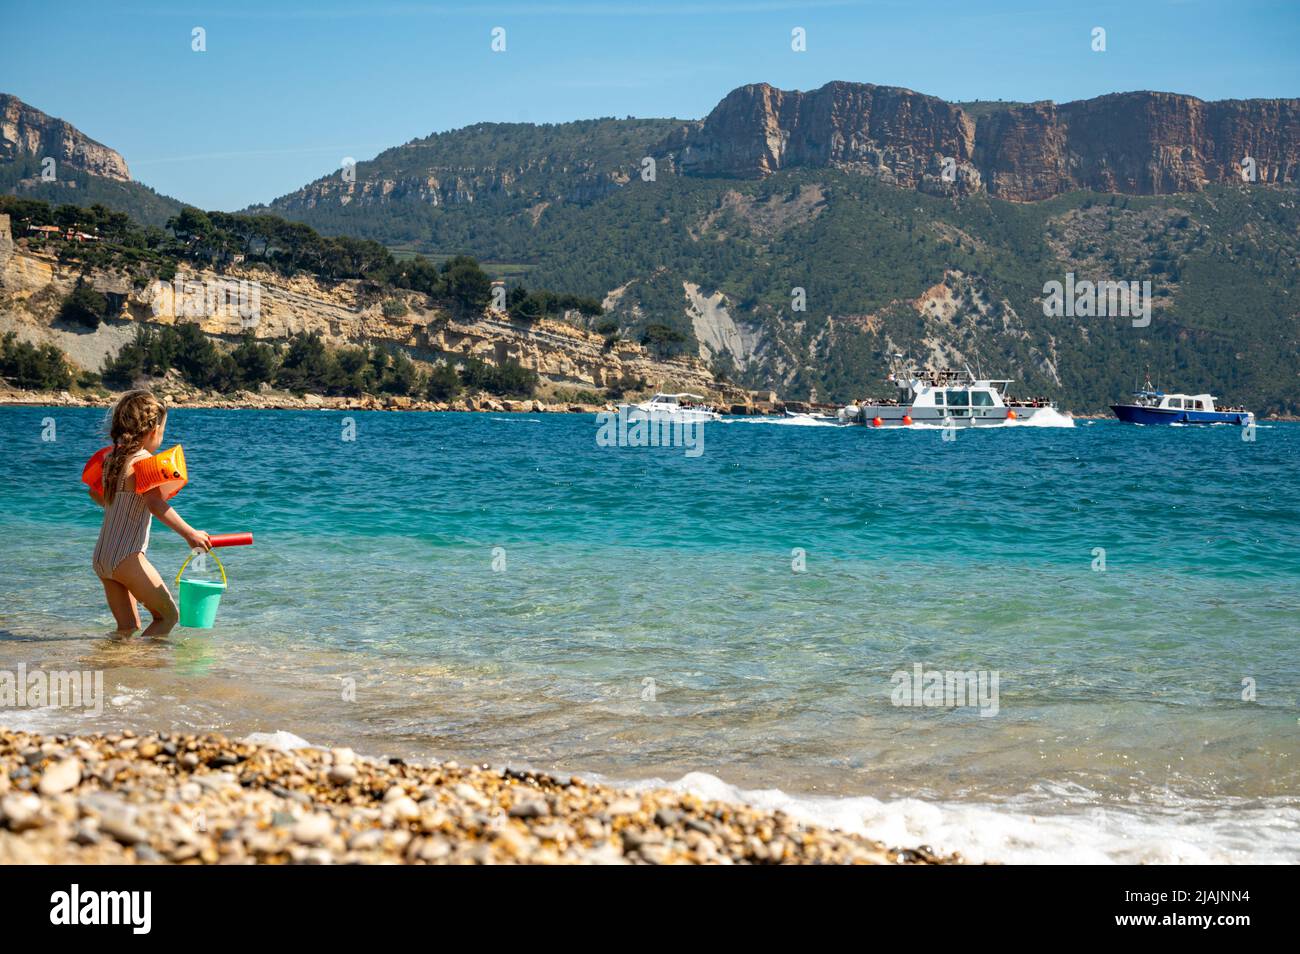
[[839, 355, 1060, 428]]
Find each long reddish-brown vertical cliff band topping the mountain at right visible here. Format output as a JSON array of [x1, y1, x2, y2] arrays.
[[660, 83, 1300, 201]]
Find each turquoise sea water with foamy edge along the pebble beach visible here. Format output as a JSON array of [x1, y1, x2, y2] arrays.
[[0, 408, 1300, 860]]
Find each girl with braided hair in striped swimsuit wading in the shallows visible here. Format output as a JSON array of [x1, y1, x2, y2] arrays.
[[90, 390, 212, 636]]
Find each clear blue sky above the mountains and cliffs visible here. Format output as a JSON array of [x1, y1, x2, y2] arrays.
[[0, 0, 1300, 209]]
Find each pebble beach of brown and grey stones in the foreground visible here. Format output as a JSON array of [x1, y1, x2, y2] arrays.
[[0, 729, 961, 864]]
